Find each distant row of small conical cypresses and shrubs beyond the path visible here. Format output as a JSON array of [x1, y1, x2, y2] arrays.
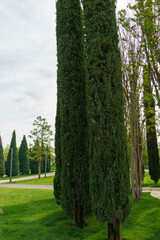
[[0, 131, 51, 177]]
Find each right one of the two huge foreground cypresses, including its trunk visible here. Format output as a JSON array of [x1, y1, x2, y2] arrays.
[[83, 0, 130, 240]]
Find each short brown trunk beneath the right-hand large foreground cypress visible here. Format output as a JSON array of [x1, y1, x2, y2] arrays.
[[108, 220, 122, 240]]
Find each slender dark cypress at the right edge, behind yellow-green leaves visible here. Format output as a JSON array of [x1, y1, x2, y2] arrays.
[[143, 67, 160, 183]]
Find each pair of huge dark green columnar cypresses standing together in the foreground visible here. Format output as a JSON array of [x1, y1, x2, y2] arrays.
[[54, 0, 130, 240]]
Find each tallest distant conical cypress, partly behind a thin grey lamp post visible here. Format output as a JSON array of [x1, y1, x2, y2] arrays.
[[6, 131, 20, 176]]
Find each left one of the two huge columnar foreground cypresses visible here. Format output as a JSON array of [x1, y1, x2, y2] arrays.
[[56, 0, 89, 227]]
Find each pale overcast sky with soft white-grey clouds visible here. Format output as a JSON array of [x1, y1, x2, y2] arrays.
[[0, 0, 127, 147]]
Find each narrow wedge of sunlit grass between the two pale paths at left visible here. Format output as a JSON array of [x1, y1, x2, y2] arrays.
[[12, 176, 53, 185]]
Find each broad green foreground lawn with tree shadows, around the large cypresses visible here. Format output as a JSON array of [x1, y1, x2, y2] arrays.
[[0, 188, 160, 240]]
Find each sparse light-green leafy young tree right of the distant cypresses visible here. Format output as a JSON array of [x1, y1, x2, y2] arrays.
[[29, 116, 53, 178]]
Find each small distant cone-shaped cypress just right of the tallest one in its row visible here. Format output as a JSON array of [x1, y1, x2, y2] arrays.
[[18, 135, 29, 174]]
